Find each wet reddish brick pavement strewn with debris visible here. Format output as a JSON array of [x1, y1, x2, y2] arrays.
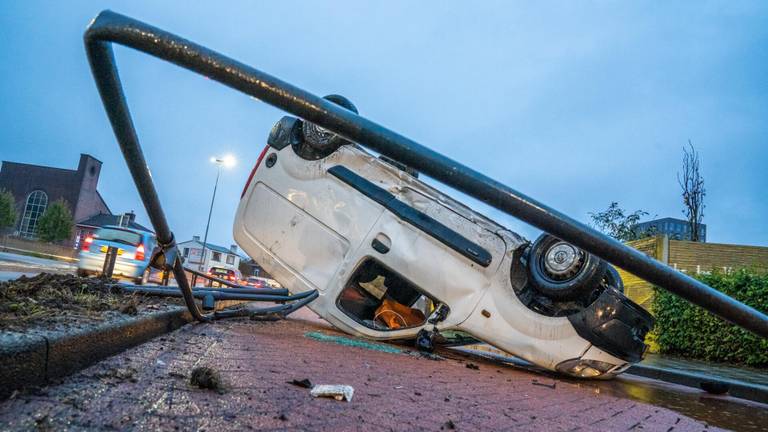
[[0, 314, 728, 431]]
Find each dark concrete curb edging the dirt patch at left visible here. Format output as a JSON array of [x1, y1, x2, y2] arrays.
[[0, 307, 192, 399]]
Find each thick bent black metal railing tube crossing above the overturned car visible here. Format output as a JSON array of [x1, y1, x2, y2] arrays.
[[84, 11, 768, 338]]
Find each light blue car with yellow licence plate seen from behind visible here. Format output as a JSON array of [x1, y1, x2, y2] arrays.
[[77, 226, 157, 285]]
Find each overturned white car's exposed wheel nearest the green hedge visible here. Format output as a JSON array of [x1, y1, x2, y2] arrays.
[[528, 234, 607, 301]]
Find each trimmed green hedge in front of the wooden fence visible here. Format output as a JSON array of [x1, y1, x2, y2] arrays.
[[653, 270, 768, 367]]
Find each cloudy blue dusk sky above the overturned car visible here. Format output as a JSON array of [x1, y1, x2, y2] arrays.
[[0, 1, 768, 246]]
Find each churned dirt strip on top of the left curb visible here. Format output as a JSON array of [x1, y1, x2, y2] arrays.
[[0, 273, 153, 329]]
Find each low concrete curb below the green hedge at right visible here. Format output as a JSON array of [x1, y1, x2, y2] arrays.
[[626, 364, 768, 404]]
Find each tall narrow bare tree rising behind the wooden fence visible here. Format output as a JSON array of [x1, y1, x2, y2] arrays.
[[677, 140, 707, 241]]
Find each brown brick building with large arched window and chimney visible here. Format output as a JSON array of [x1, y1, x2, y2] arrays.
[[0, 154, 112, 244]]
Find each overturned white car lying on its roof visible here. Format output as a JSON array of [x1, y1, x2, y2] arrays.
[[234, 95, 653, 378]]
